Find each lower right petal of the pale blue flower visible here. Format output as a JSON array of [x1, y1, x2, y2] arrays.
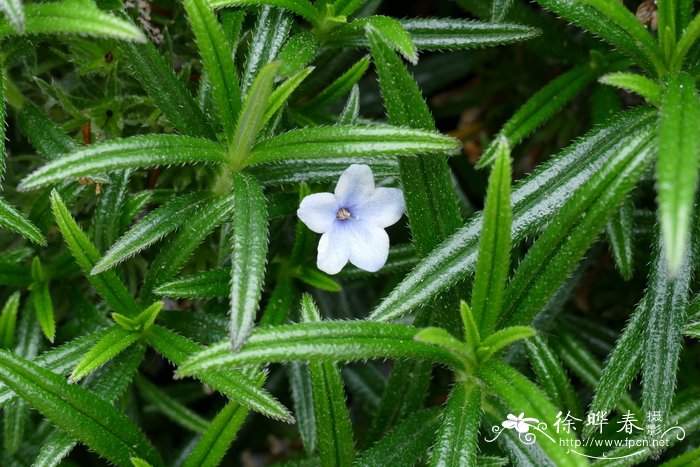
[[348, 221, 389, 272]]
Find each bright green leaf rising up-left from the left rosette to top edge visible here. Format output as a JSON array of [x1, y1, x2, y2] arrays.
[[184, 0, 241, 142]]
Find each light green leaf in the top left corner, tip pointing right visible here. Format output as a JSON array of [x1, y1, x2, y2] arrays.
[[0, 0, 147, 42]]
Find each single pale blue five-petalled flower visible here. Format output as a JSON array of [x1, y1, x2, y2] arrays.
[[297, 164, 406, 274]]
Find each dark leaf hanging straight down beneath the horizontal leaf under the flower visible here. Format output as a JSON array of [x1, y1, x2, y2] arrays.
[[287, 362, 317, 456]]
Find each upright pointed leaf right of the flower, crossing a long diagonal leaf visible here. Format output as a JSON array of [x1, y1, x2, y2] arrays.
[[471, 139, 512, 337]]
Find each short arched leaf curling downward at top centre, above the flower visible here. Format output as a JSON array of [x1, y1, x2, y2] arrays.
[[325, 15, 418, 65]]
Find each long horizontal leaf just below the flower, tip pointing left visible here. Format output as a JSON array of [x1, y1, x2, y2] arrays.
[[178, 321, 463, 376]]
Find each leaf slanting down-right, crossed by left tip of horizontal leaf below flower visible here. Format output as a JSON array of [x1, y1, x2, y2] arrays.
[[146, 325, 294, 422]]
